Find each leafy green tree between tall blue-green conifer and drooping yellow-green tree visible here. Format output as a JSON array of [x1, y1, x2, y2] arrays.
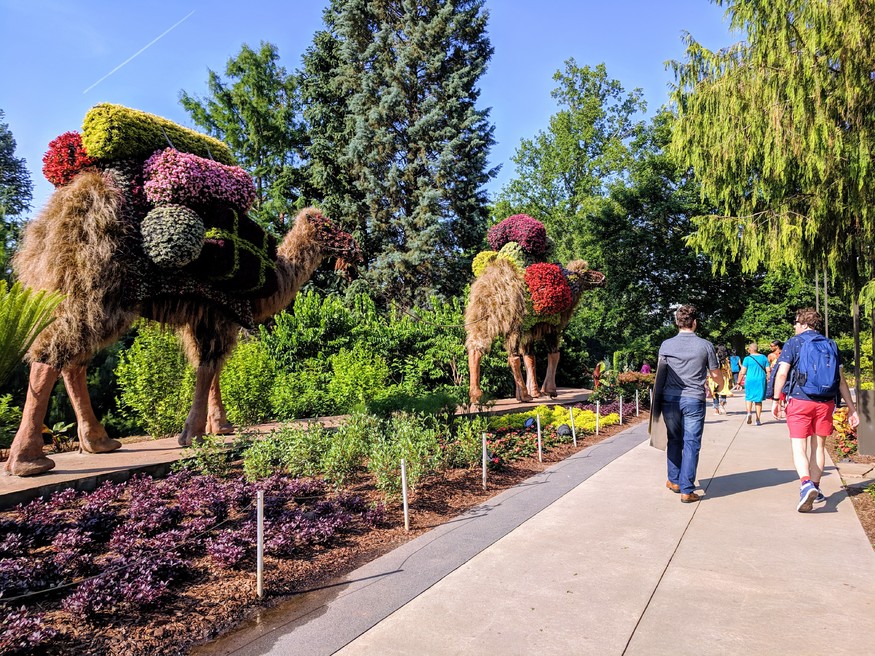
[[495, 59, 645, 261]]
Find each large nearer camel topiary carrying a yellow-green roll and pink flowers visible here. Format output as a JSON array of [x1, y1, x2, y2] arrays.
[[6, 106, 358, 476]]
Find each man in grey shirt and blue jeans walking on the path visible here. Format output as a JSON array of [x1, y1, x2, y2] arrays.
[[659, 305, 723, 503]]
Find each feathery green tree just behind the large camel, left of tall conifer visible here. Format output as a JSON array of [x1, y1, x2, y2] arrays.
[[179, 43, 310, 234]]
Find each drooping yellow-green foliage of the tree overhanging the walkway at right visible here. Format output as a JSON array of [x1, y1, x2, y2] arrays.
[[673, 0, 875, 302]]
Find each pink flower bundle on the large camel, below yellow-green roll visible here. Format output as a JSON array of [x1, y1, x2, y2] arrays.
[[143, 148, 255, 212]]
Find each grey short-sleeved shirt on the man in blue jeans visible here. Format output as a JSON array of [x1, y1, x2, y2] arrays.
[[659, 333, 719, 401]]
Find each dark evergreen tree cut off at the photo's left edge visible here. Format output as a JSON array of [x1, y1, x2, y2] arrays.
[[0, 109, 33, 278]]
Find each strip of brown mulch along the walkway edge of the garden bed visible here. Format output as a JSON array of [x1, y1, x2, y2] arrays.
[[5, 412, 647, 656]]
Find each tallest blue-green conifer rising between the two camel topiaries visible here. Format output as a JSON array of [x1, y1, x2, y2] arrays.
[[302, 0, 495, 305]]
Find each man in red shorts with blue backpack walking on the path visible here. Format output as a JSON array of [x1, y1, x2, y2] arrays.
[[772, 308, 860, 512]]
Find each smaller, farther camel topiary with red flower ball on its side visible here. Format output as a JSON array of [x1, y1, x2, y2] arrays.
[[465, 215, 605, 405]]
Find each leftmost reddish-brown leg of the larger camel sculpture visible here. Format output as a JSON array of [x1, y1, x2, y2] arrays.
[[5, 362, 61, 476]]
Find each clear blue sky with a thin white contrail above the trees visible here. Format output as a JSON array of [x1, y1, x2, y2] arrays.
[[0, 0, 738, 218]]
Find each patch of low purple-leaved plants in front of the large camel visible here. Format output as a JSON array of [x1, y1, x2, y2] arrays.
[[0, 470, 382, 653]]
